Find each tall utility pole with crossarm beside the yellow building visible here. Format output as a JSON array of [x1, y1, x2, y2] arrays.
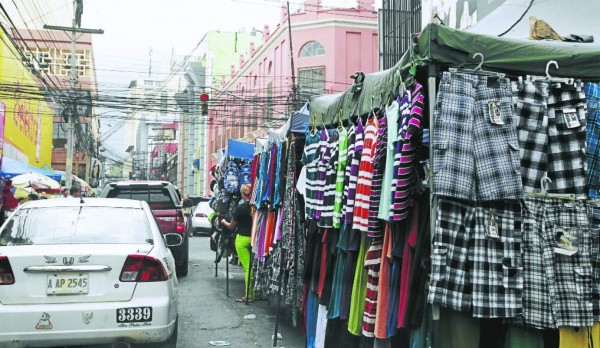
[[44, 0, 104, 189]]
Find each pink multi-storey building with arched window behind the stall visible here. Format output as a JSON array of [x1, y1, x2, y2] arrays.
[[206, 0, 378, 190]]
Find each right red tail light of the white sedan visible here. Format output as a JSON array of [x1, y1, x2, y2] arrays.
[[119, 255, 169, 283]]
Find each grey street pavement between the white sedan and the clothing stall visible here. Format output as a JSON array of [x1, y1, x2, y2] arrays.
[[177, 236, 305, 348]]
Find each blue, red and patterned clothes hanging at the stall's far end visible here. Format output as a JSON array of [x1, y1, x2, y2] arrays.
[[250, 134, 304, 328]]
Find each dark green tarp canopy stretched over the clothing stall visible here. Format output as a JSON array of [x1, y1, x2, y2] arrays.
[[310, 23, 600, 126]]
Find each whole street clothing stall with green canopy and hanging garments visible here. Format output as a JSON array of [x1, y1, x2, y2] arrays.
[[246, 24, 600, 347]]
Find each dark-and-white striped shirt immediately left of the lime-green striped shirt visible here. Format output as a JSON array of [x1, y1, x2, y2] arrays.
[[318, 131, 339, 228]]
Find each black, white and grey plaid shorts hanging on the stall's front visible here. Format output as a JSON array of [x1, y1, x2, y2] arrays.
[[428, 72, 600, 347]]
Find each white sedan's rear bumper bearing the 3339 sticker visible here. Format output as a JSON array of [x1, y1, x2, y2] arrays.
[[0, 297, 177, 348]]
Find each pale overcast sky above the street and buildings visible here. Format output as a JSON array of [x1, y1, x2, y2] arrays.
[[2, 0, 380, 159]]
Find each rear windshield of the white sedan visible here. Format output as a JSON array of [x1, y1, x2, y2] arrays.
[[0, 207, 153, 246]]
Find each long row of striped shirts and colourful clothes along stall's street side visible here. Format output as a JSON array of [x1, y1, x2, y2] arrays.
[[247, 84, 429, 347]]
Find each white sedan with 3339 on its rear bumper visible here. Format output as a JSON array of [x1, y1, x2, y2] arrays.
[[0, 198, 181, 348]]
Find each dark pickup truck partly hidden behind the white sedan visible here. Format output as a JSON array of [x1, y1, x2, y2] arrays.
[[101, 181, 191, 277]]
